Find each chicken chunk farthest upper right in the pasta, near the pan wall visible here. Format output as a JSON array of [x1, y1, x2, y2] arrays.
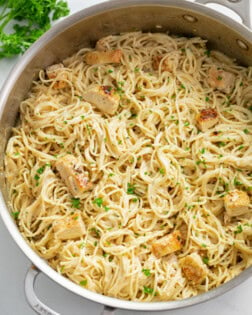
[[207, 67, 235, 93]]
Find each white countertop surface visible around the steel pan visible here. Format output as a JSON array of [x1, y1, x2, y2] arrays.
[[0, 0, 252, 315]]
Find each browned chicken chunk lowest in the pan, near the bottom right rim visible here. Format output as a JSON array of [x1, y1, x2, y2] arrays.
[[179, 253, 207, 284]]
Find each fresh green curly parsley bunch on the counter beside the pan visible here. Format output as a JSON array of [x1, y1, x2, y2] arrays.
[[0, 0, 70, 58]]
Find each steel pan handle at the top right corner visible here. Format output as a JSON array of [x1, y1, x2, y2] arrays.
[[196, 0, 251, 28]]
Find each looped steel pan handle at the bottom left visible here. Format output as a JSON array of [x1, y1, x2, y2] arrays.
[[25, 265, 115, 315]]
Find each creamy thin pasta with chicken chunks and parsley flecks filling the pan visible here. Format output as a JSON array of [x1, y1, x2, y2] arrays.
[[5, 32, 252, 302]]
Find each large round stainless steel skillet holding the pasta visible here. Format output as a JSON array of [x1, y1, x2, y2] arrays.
[[0, 0, 252, 315]]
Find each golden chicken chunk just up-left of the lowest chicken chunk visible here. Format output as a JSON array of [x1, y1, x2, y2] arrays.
[[152, 231, 182, 258]]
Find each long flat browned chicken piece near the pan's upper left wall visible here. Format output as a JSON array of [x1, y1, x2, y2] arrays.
[[85, 49, 122, 65]]
